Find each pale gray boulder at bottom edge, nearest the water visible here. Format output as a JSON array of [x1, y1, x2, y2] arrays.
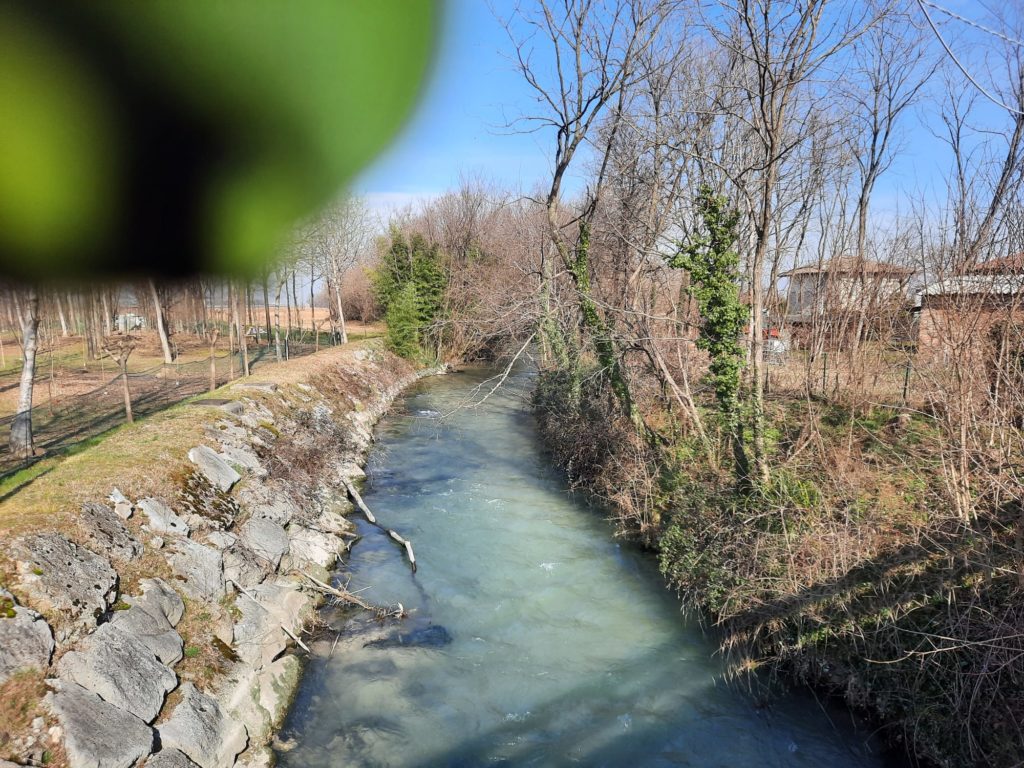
[[159, 683, 248, 768]]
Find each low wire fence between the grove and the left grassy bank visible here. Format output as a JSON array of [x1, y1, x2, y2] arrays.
[[0, 341, 316, 477]]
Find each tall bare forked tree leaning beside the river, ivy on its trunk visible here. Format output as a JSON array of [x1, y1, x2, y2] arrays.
[[506, 0, 679, 427]]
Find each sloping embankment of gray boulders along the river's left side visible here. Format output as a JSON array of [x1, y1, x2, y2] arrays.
[[0, 346, 428, 768]]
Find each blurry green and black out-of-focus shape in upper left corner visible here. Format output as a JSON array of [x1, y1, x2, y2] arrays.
[[0, 0, 440, 280]]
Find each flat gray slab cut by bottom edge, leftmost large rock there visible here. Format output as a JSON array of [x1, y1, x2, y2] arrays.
[[47, 680, 154, 768]]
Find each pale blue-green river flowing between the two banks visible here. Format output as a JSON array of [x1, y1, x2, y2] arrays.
[[279, 373, 897, 768]]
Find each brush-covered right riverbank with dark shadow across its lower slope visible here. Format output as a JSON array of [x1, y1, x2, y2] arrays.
[[536, 374, 1024, 766]]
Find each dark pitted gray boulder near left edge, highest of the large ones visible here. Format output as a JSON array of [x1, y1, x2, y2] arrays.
[[11, 534, 118, 642]]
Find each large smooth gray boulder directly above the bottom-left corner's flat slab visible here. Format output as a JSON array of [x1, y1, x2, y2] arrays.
[[57, 624, 178, 723]]
